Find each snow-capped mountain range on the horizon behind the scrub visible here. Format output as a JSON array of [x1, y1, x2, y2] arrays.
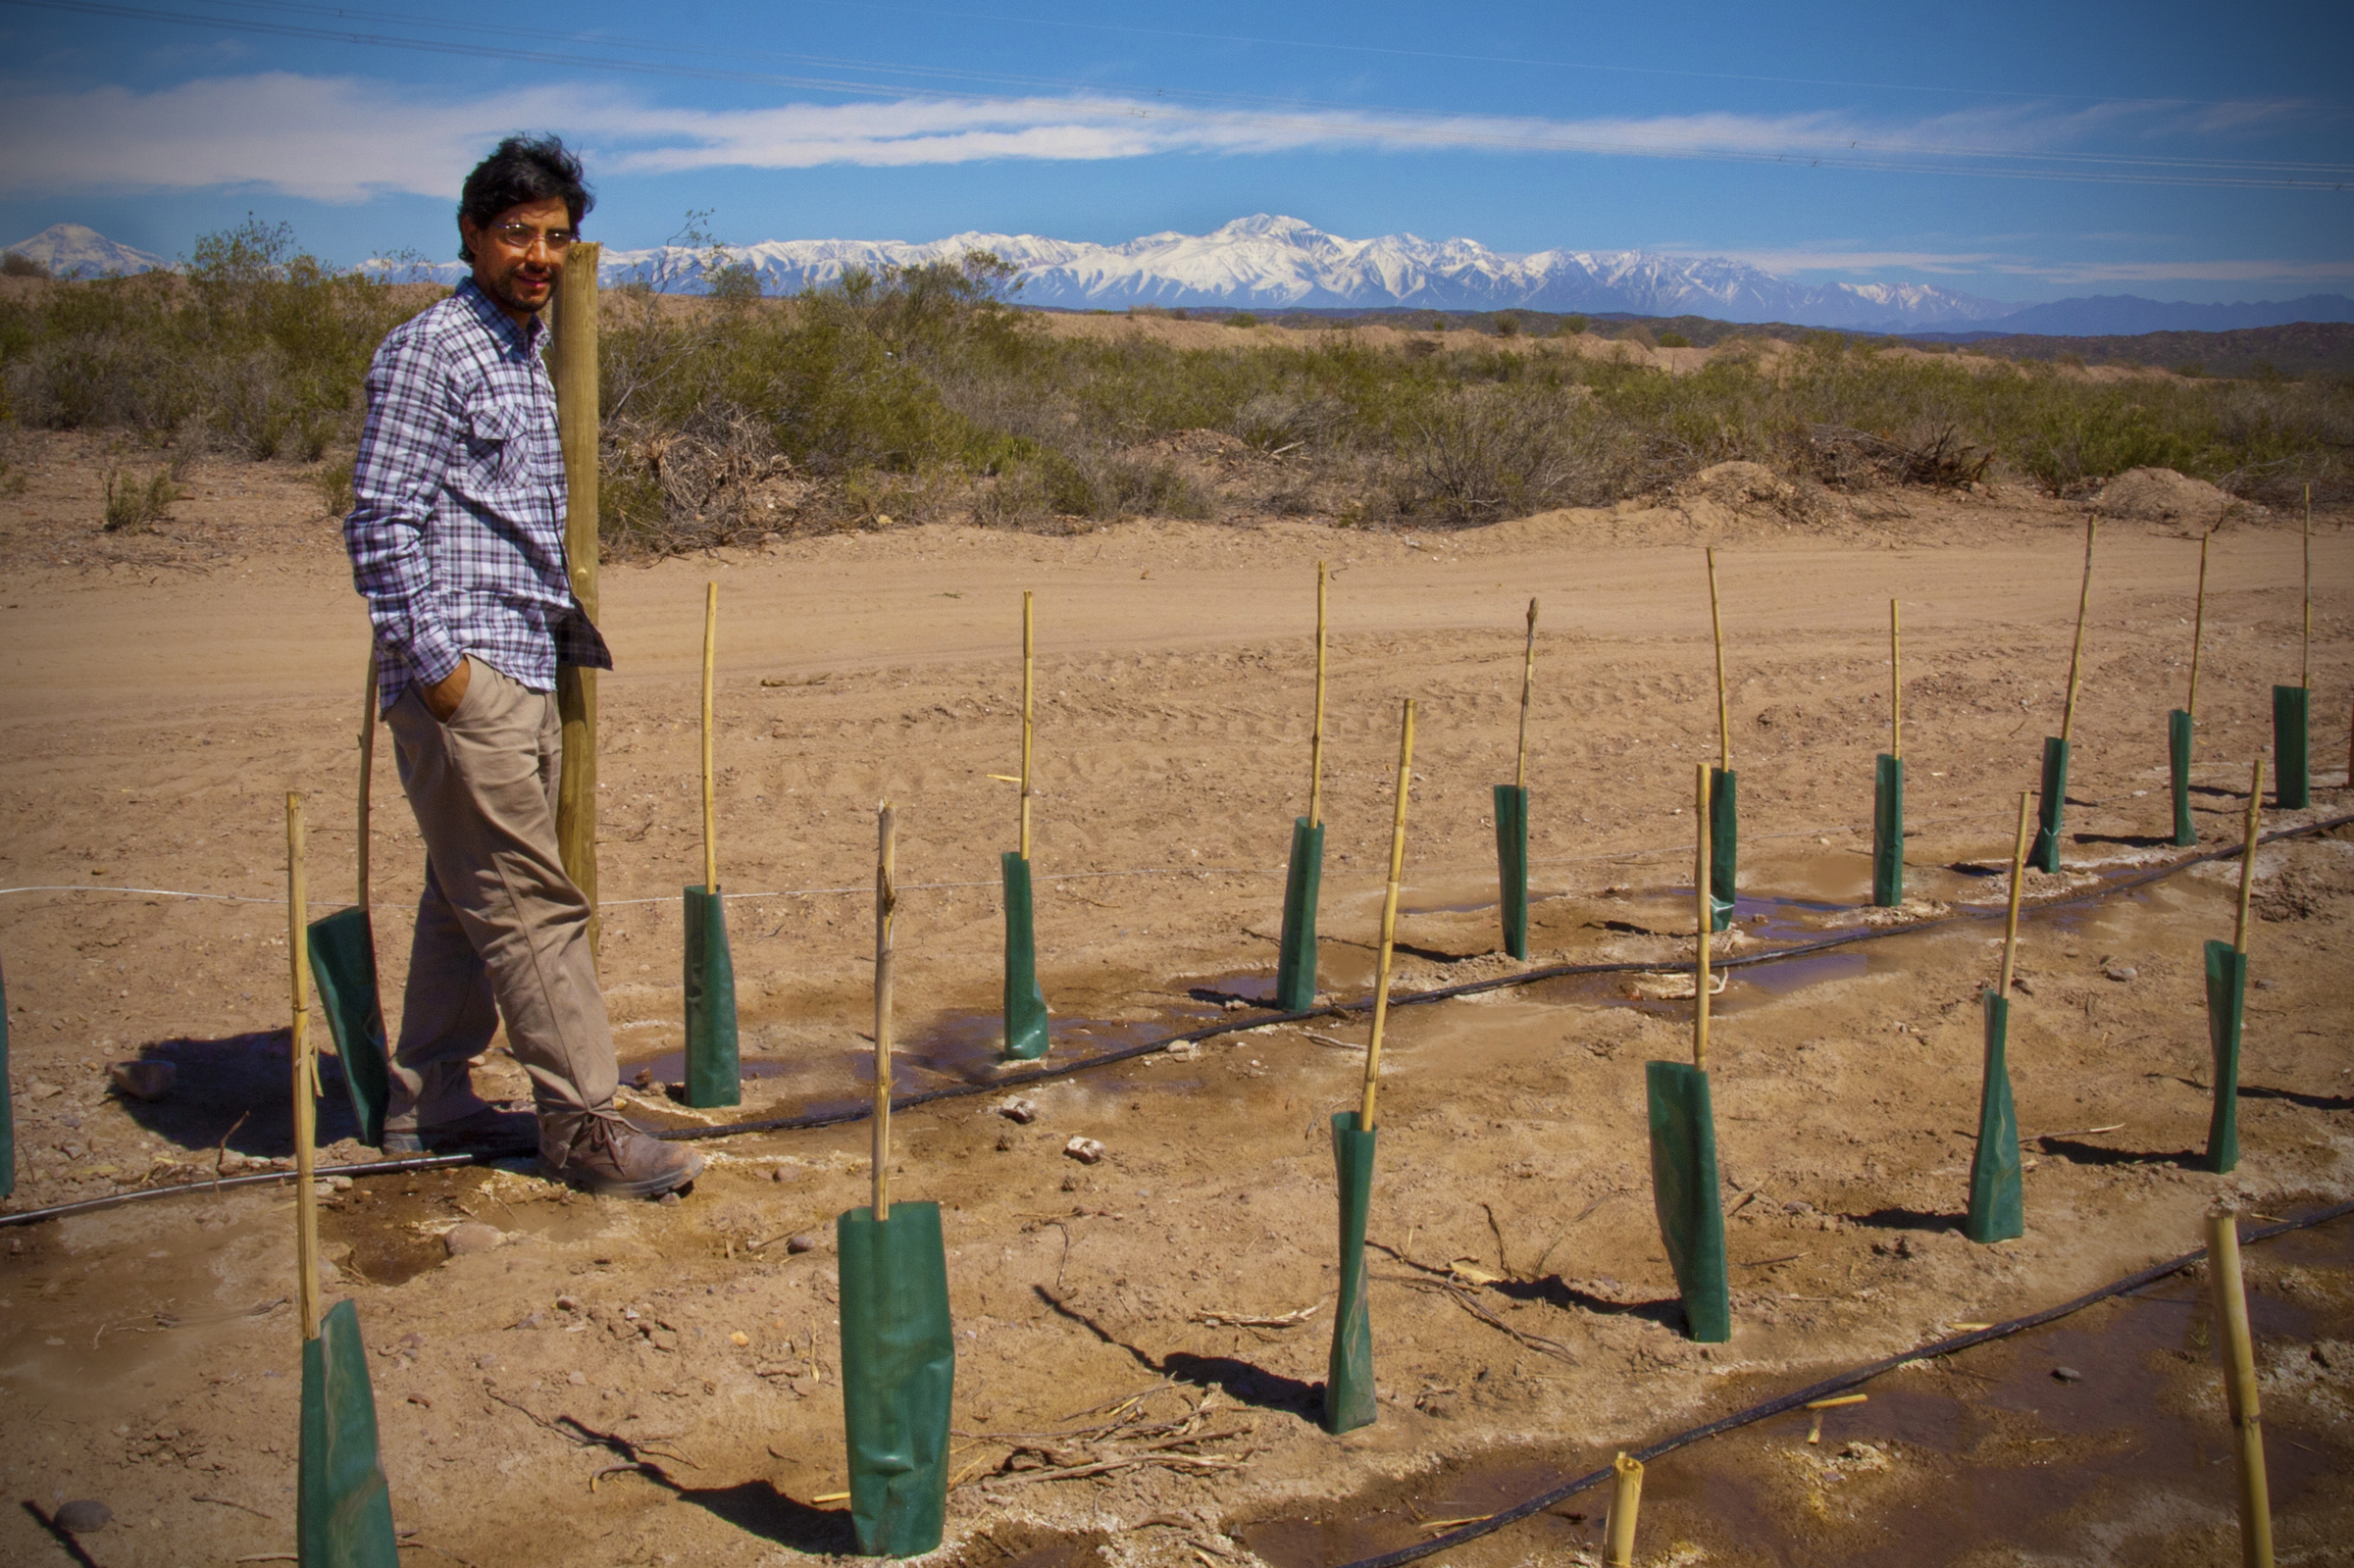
[[7, 212, 2354, 334]]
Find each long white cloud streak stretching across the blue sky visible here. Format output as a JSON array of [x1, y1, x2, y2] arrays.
[[0, 71, 2316, 198]]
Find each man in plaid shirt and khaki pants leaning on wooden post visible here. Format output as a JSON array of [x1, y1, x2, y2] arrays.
[[343, 136, 704, 1196]]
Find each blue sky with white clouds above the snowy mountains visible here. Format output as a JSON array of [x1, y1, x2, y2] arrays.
[[0, 0, 2354, 299]]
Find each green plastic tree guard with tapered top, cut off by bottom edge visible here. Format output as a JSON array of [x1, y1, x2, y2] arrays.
[[294, 1297, 400, 1568]]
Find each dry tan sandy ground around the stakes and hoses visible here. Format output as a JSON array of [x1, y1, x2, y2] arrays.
[[0, 438, 2354, 1568]]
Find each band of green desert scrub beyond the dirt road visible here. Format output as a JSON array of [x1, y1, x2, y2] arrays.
[[0, 224, 2354, 541]]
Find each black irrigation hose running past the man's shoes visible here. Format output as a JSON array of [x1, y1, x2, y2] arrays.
[[0, 812, 2354, 1234]]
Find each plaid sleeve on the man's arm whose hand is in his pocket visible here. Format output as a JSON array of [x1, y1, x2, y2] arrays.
[[343, 332, 466, 685]]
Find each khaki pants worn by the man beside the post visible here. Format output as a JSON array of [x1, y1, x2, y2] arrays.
[[386, 659, 614, 1128]]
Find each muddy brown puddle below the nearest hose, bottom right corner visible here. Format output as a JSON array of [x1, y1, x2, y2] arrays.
[[1204, 1220, 2354, 1568]]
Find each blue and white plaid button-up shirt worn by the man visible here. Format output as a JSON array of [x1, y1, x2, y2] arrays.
[[343, 278, 612, 706]]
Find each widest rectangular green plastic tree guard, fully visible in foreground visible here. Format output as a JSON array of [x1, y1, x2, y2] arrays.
[[834, 1203, 955, 1556]]
